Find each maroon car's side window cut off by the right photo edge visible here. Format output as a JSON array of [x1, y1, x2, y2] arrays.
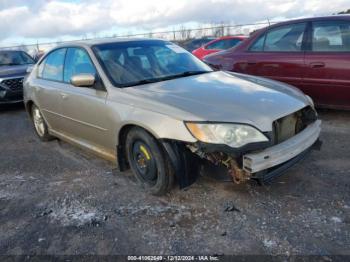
[[312, 21, 350, 52]]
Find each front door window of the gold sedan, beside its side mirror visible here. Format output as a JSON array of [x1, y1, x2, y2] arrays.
[[64, 48, 96, 83]]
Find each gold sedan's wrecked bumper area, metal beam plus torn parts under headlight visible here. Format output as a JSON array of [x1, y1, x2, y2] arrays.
[[187, 120, 321, 183]]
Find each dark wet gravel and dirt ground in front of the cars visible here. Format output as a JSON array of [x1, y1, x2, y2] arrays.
[[0, 103, 350, 255]]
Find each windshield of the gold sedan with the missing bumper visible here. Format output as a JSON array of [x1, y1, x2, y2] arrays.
[[93, 40, 212, 87]]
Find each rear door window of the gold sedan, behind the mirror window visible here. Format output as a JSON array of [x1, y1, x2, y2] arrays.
[[39, 48, 66, 81]]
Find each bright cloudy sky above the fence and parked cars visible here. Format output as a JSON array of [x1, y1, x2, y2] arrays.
[[0, 0, 350, 46]]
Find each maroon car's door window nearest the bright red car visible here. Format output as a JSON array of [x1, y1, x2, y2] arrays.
[[263, 23, 306, 52]]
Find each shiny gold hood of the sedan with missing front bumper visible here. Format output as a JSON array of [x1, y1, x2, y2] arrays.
[[127, 71, 311, 131]]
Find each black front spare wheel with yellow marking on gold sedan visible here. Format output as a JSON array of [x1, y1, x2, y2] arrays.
[[126, 127, 174, 196]]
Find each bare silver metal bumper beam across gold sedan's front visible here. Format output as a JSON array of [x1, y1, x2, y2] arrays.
[[243, 120, 321, 173]]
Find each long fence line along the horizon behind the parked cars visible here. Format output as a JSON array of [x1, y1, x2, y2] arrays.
[[0, 22, 270, 56]]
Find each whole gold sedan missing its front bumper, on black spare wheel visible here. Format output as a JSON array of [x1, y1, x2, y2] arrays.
[[24, 39, 321, 195]]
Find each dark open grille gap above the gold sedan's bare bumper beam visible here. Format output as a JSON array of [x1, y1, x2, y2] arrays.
[[273, 107, 317, 144]]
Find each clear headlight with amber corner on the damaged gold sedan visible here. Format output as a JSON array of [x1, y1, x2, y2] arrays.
[[185, 122, 269, 148]]
